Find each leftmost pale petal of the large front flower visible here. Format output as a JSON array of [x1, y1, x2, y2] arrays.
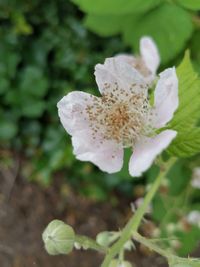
[[57, 91, 95, 135]]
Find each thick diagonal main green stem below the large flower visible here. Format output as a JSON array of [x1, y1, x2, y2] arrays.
[[101, 158, 175, 267]]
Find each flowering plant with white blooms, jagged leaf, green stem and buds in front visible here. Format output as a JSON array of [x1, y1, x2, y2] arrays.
[[43, 36, 200, 267]]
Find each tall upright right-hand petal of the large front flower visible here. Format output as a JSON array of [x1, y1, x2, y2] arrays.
[[152, 68, 179, 128]]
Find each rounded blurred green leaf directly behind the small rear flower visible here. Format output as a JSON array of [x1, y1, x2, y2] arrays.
[[124, 4, 193, 63]]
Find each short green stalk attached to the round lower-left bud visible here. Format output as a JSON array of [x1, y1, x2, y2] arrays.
[[75, 235, 107, 253]]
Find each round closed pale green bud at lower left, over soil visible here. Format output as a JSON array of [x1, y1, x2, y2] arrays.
[[42, 220, 75, 255]]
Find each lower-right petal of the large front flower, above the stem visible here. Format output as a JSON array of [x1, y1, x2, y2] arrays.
[[129, 130, 177, 177]]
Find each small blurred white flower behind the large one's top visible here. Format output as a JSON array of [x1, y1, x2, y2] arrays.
[[116, 36, 160, 84]]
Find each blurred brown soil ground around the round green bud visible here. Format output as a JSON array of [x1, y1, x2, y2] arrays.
[[0, 155, 195, 267]]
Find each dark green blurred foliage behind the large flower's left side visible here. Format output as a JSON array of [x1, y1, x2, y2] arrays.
[[0, 0, 130, 195]]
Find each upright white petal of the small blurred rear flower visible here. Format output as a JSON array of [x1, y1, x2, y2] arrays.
[[140, 37, 160, 75]]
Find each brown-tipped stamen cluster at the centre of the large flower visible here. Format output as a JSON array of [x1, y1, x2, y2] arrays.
[[83, 85, 149, 147]]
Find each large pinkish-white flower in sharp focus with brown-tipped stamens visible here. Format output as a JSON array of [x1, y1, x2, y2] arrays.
[[58, 58, 178, 176]]
